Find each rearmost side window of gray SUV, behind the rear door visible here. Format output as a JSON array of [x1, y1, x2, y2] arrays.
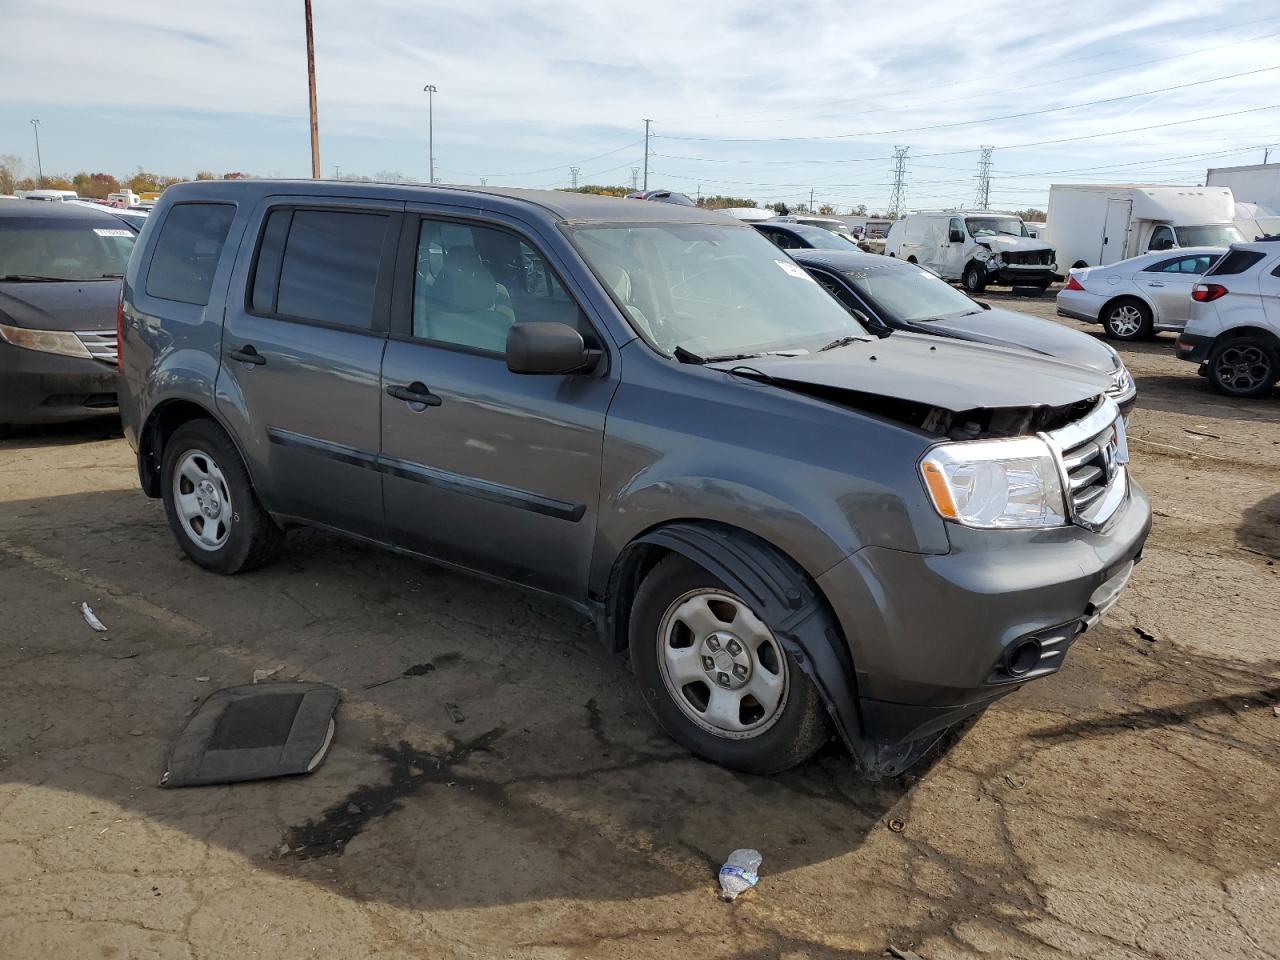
[[146, 204, 236, 307]]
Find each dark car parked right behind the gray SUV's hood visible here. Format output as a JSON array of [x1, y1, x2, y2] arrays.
[[791, 250, 1138, 416]]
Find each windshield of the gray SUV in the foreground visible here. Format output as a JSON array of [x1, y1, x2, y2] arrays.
[[572, 223, 867, 358]]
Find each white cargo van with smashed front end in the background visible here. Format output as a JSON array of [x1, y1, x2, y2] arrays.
[[884, 210, 1056, 293]]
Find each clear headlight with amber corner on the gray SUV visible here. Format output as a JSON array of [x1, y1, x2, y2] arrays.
[[920, 436, 1066, 529]]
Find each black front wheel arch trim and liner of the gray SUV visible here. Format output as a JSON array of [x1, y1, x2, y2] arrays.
[[600, 520, 864, 756]]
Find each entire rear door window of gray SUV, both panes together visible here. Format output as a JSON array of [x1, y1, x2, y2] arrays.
[[250, 209, 390, 330]]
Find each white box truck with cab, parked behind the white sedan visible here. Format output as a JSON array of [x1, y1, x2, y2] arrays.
[[1046, 183, 1244, 274]]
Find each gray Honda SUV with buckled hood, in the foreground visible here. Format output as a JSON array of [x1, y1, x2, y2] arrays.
[[120, 180, 1151, 777]]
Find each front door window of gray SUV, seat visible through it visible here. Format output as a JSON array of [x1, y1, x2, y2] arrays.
[[413, 220, 585, 353]]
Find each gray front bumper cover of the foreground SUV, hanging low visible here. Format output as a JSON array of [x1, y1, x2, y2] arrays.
[[818, 479, 1151, 776]]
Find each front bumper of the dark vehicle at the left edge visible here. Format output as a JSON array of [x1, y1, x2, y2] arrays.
[[0, 343, 118, 424]]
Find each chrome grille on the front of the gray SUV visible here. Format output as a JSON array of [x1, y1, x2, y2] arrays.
[[1044, 399, 1129, 527]]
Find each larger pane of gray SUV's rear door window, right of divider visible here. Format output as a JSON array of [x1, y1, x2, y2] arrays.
[[273, 210, 388, 330]]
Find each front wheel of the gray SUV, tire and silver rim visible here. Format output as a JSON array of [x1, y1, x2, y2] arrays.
[[630, 556, 835, 774]]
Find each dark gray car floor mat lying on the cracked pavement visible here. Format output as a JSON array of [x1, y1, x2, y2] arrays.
[[160, 681, 340, 787]]
